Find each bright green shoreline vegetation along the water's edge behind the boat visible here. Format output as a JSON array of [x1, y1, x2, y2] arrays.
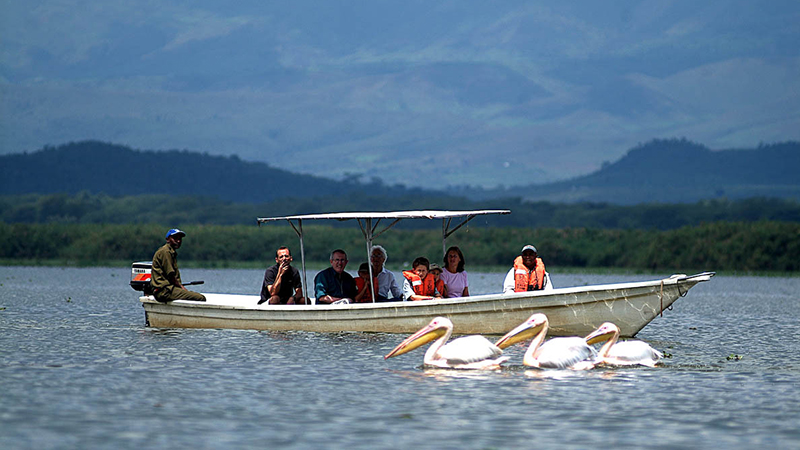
[[0, 221, 800, 275]]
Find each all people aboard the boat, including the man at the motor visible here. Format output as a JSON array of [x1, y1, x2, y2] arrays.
[[151, 229, 551, 305]]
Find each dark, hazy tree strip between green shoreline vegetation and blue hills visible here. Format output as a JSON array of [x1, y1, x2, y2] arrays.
[[0, 191, 800, 230]]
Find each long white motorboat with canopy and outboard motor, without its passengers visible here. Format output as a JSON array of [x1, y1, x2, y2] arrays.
[[131, 210, 714, 337]]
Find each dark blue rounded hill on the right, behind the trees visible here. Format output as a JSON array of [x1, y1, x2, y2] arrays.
[[451, 139, 800, 205]]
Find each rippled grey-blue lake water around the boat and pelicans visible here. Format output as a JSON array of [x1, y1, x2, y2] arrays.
[[0, 267, 800, 449]]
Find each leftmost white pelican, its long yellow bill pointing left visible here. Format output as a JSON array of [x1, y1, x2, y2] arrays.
[[383, 317, 508, 369]]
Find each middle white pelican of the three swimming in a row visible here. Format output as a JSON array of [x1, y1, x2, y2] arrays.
[[496, 314, 597, 370]]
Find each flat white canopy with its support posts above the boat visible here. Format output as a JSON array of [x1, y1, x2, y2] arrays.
[[256, 209, 511, 303]]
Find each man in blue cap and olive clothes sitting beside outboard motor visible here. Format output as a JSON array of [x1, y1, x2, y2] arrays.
[[150, 228, 206, 302]]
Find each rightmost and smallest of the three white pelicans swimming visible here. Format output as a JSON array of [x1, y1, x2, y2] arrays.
[[586, 322, 661, 367]]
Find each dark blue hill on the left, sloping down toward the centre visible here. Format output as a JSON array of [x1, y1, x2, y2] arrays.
[[0, 141, 424, 203]]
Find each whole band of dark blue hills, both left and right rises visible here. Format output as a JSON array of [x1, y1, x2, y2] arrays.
[[0, 139, 800, 206]]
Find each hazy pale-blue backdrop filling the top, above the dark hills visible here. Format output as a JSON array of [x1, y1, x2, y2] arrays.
[[0, 0, 800, 186]]
